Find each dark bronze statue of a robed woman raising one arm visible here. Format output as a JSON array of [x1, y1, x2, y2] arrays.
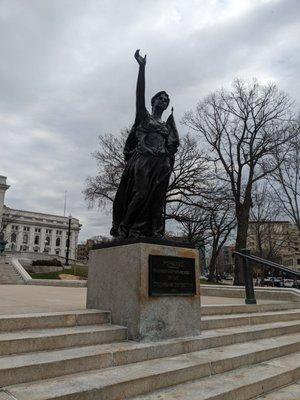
[[111, 50, 179, 239]]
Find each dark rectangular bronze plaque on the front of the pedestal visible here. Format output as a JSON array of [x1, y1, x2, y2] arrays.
[[149, 255, 196, 296]]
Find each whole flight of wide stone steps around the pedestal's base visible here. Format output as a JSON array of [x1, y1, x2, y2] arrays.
[[0, 302, 300, 400]]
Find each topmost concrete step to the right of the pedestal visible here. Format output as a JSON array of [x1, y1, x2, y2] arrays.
[[201, 302, 300, 317]]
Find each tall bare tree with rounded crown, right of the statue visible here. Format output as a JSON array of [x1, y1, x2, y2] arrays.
[[183, 80, 294, 284]]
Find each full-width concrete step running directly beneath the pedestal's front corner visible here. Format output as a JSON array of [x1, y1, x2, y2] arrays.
[[0, 322, 300, 384]]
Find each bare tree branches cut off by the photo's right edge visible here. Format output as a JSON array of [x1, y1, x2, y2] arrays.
[[269, 124, 300, 234]]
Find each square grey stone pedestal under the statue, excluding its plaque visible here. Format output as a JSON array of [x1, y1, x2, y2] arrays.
[[87, 242, 200, 341]]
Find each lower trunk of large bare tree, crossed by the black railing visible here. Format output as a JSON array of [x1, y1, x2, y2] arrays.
[[233, 205, 250, 285]]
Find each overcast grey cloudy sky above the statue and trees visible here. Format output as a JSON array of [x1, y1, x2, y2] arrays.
[[0, 0, 300, 240]]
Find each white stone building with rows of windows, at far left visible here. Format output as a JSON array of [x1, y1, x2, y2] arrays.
[[0, 176, 81, 259]]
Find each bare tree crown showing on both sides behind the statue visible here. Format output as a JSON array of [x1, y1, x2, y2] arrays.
[[83, 130, 209, 219]]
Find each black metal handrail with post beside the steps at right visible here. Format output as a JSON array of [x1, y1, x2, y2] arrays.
[[233, 249, 300, 304]]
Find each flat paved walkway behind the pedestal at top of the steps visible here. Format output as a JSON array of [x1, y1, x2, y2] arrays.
[[0, 285, 284, 315]]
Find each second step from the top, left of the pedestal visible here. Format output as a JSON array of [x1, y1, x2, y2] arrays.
[[0, 324, 127, 355]]
